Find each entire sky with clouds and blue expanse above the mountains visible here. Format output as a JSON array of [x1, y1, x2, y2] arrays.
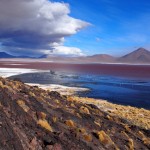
[[0, 0, 150, 56]]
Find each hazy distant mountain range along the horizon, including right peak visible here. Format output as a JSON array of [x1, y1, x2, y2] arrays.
[[0, 48, 150, 63]]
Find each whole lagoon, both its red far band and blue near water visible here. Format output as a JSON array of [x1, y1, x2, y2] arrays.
[[0, 62, 150, 109]]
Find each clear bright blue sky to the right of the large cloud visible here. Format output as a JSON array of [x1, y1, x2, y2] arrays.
[[54, 0, 150, 56]]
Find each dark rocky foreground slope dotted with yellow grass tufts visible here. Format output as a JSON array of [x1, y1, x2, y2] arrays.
[[0, 78, 150, 150]]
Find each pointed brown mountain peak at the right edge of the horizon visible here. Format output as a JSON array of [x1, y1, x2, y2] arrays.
[[118, 48, 150, 63]]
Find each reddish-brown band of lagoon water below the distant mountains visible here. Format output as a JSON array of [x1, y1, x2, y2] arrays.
[[0, 61, 150, 79]]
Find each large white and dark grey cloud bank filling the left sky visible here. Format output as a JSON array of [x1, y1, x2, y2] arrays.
[[0, 0, 89, 54]]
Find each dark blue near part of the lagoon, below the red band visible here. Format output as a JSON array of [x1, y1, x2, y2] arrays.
[[8, 71, 150, 109]]
